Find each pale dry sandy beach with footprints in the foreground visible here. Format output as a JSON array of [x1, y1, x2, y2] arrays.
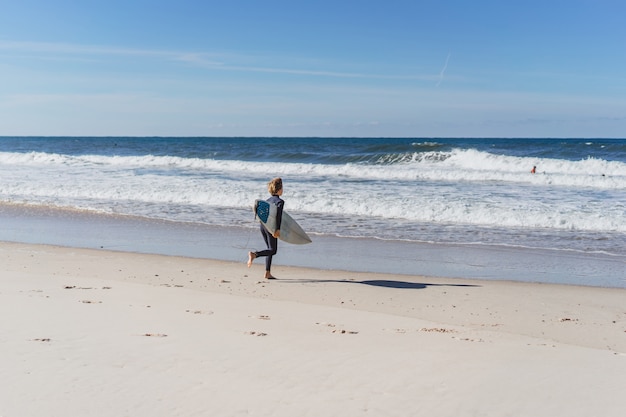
[[0, 243, 626, 417]]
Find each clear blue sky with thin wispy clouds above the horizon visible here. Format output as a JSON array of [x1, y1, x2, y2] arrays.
[[0, 0, 626, 138]]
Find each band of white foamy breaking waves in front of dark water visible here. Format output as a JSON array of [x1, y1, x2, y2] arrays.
[[0, 150, 626, 234]]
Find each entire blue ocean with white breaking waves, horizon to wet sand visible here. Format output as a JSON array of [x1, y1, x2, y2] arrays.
[[0, 137, 626, 286]]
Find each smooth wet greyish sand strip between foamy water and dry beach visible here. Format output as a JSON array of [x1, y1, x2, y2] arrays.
[[0, 204, 626, 288]]
